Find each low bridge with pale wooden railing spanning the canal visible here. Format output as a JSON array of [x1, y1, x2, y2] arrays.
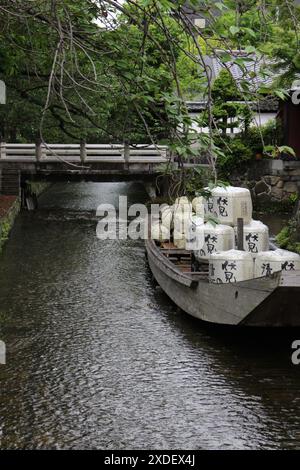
[[0, 142, 169, 195]]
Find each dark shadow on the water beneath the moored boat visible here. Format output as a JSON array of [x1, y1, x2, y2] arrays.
[[151, 280, 300, 410]]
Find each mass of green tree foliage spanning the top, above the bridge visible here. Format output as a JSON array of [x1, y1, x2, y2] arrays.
[[0, 0, 300, 191]]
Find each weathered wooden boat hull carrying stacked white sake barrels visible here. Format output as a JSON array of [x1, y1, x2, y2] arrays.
[[146, 239, 300, 327]]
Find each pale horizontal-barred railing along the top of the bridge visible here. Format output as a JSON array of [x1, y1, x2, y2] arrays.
[[0, 142, 168, 163]]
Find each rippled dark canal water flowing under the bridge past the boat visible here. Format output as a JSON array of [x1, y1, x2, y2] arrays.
[[0, 183, 300, 449]]
